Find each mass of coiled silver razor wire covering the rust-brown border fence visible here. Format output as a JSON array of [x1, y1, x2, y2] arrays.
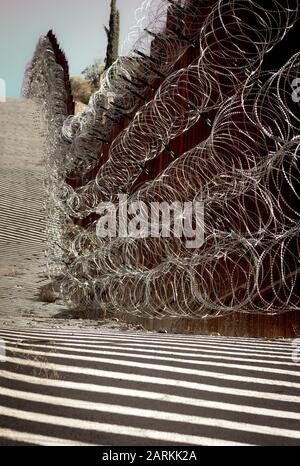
[[27, 0, 300, 318]]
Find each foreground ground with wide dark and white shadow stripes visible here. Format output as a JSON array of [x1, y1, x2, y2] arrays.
[[0, 328, 300, 446]]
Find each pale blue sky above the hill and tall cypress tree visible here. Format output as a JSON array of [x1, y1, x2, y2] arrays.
[[0, 0, 141, 97]]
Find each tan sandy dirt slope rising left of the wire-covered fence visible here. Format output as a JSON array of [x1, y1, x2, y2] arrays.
[[0, 99, 137, 331]]
